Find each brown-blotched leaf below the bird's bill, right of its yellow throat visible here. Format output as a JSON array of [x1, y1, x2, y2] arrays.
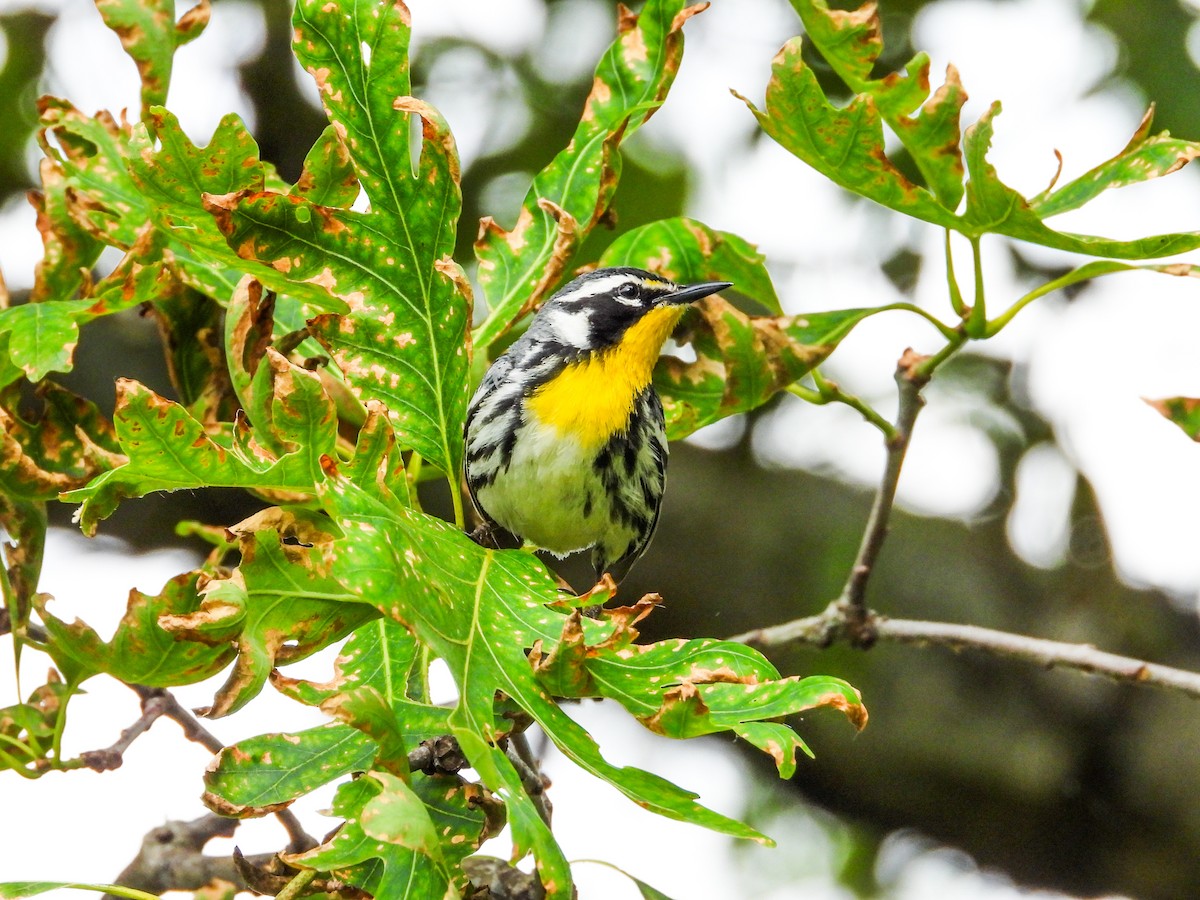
[[654, 296, 880, 440]]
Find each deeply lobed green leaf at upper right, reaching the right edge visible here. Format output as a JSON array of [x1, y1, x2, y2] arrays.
[[743, 0, 1200, 259]]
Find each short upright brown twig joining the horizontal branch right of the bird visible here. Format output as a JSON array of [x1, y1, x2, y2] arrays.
[[838, 349, 929, 647]]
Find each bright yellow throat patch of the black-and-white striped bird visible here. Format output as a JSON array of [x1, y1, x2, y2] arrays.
[[527, 306, 688, 449]]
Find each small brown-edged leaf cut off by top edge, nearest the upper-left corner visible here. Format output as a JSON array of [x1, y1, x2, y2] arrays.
[[96, 0, 210, 116]]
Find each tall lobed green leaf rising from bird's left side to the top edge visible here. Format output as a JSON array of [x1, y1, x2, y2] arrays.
[[280, 0, 470, 473]]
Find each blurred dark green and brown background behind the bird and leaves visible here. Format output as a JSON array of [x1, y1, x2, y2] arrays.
[[0, 0, 1200, 900]]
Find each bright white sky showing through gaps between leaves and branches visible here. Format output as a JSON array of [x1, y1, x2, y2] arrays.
[[0, 0, 1180, 900]]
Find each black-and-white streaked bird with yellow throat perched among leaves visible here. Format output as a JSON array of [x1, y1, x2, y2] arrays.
[[466, 268, 731, 581]]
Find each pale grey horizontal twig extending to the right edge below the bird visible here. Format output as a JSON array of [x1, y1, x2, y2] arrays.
[[730, 602, 1200, 698]]
